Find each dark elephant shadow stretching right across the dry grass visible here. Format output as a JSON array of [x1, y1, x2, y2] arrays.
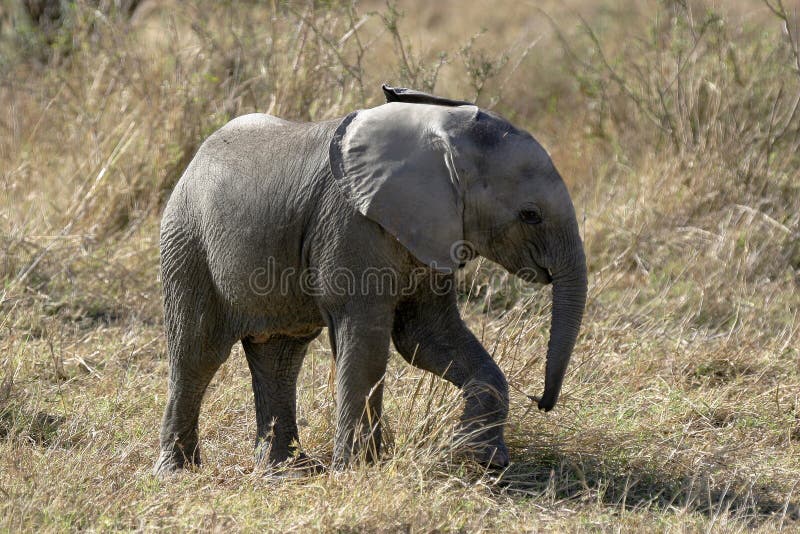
[[493, 448, 800, 526]]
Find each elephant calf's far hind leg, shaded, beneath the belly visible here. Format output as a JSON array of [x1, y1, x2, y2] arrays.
[[242, 330, 319, 464]]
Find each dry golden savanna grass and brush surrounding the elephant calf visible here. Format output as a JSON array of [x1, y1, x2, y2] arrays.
[[0, 0, 800, 532]]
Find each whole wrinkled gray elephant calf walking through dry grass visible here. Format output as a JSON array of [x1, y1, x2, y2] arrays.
[[155, 88, 586, 474]]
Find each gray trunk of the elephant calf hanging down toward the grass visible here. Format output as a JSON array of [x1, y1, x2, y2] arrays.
[[539, 245, 587, 412]]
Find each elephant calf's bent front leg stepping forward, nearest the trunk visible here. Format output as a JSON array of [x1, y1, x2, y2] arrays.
[[392, 294, 509, 467]]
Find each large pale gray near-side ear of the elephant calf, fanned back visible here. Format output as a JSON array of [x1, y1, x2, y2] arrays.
[[330, 102, 477, 271]]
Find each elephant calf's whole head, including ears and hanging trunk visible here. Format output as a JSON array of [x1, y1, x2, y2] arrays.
[[330, 86, 587, 411]]
